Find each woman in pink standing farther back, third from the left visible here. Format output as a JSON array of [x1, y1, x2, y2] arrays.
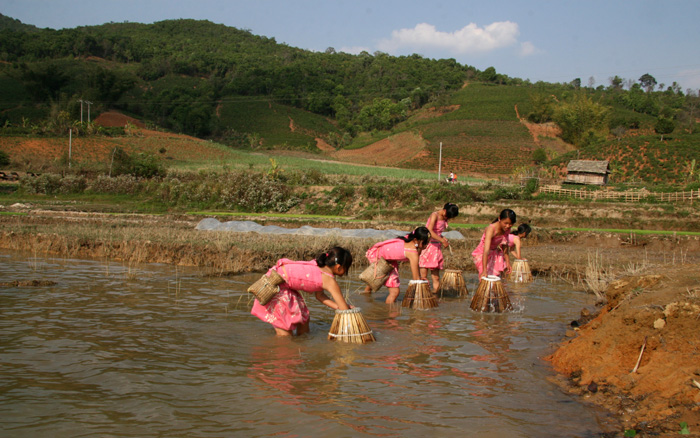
[[419, 202, 459, 293]]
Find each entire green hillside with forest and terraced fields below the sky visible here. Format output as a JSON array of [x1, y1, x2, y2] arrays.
[[0, 16, 700, 183]]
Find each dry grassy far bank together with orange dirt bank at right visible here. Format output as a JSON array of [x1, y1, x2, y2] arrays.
[[0, 210, 700, 435]]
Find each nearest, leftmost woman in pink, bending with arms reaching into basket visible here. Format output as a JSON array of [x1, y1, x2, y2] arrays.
[[250, 246, 352, 336]]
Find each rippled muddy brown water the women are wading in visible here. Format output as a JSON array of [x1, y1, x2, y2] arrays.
[[0, 253, 611, 437]]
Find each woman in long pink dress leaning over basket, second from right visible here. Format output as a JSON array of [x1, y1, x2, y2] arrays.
[[472, 208, 516, 278]]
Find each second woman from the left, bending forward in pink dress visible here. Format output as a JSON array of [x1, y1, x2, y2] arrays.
[[365, 227, 430, 304]]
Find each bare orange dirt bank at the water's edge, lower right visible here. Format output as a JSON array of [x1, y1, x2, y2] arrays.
[[548, 264, 700, 436]]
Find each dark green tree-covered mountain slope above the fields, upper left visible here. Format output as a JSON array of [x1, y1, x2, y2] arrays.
[[0, 17, 478, 141]]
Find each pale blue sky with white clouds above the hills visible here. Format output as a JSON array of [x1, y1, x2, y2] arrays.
[[0, 0, 700, 91]]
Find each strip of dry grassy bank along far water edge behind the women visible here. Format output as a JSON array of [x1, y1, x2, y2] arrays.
[[0, 210, 700, 281]]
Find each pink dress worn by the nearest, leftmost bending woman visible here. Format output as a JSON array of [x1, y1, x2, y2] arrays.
[[250, 259, 333, 330]]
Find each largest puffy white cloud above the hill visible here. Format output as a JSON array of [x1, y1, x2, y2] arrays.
[[378, 21, 524, 54]]
